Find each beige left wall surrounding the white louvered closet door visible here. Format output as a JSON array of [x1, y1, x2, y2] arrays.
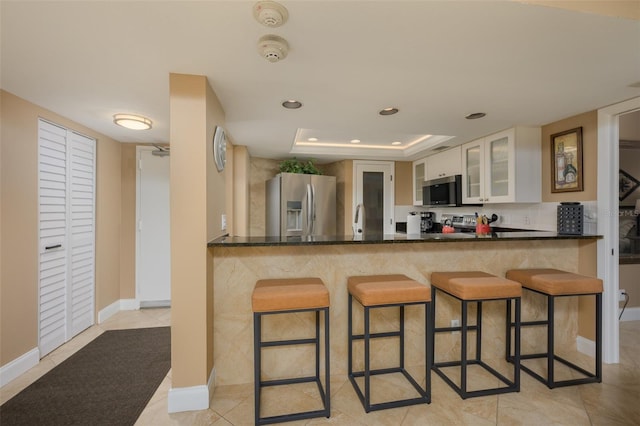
[[0, 91, 121, 365]]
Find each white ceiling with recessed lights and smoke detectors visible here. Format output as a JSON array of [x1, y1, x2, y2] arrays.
[[0, 0, 640, 162]]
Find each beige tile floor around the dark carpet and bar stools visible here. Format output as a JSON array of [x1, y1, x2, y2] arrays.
[[0, 309, 640, 426]]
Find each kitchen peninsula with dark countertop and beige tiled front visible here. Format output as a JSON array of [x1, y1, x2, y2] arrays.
[[208, 231, 600, 385]]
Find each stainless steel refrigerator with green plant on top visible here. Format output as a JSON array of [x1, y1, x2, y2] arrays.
[[266, 173, 336, 237]]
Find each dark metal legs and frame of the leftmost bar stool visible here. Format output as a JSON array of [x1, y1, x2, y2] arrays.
[[253, 308, 331, 425]]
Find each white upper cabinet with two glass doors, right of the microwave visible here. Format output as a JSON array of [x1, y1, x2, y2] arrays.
[[461, 127, 542, 204]]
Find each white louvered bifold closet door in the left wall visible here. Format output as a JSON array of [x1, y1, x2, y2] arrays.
[[38, 120, 95, 357]]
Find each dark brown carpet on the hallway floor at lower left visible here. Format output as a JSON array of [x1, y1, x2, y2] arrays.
[[0, 327, 171, 426]]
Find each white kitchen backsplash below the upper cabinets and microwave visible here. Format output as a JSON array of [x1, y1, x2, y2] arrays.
[[395, 201, 597, 234]]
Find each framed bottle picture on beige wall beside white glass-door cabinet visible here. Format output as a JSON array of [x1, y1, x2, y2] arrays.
[[551, 127, 584, 192]]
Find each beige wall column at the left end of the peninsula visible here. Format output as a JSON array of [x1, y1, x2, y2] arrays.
[[169, 74, 227, 388]]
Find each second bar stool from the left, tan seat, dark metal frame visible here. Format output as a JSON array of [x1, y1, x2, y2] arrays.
[[348, 275, 431, 413]]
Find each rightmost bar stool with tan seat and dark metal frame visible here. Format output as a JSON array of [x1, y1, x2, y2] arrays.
[[506, 269, 602, 389]]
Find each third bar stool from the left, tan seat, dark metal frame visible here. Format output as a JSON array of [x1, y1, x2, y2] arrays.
[[431, 271, 522, 399]]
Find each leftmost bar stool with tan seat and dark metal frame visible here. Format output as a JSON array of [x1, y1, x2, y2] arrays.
[[251, 278, 331, 425]]
